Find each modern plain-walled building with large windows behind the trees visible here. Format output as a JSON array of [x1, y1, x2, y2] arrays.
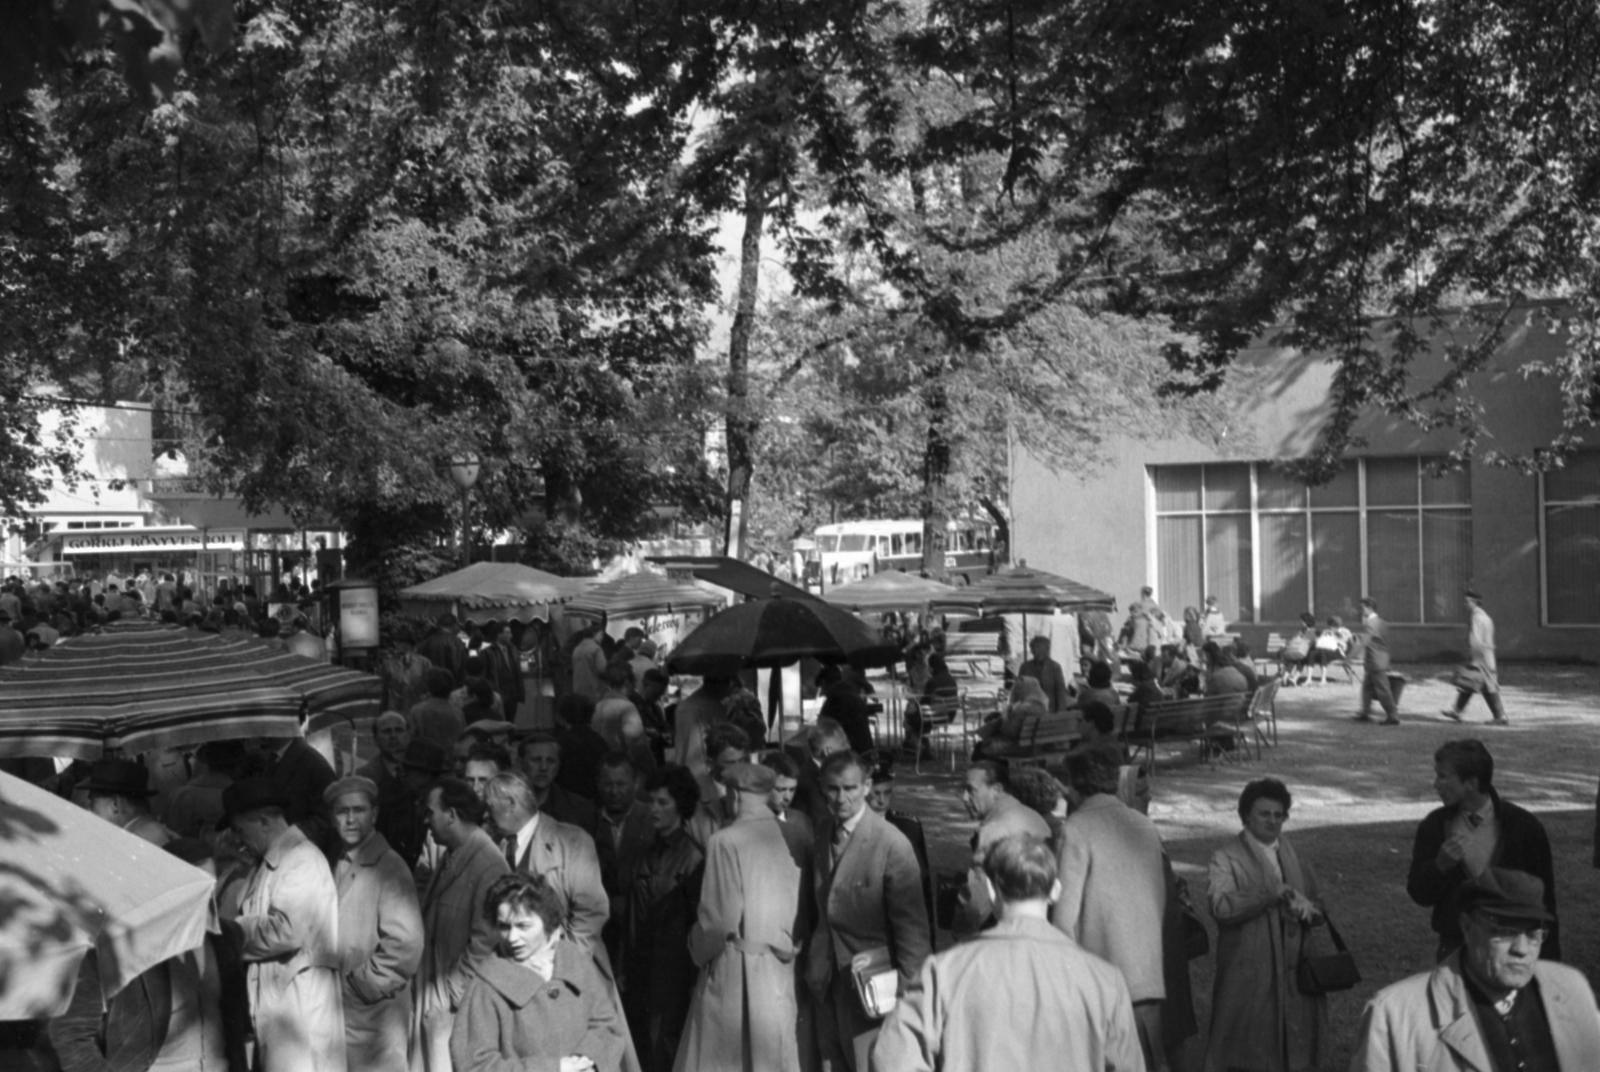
[[1011, 306, 1600, 661]]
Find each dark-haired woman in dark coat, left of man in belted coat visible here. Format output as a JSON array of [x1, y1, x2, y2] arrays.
[[622, 766, 706, 1072]]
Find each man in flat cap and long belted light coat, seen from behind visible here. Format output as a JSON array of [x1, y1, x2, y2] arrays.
[[677, 763, 802, 1072]]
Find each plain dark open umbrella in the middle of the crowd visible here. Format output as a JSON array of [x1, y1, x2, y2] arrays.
[[667, 598, 899, 677]]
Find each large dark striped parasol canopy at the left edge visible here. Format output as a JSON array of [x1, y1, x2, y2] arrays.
[[0, 622, 382, 758]]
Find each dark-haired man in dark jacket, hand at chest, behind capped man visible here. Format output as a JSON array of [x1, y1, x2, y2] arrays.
[[1405, 739, 1562, 960]]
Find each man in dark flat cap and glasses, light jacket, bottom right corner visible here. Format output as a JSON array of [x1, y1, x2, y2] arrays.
[[1350, 867, 1600, 1072]]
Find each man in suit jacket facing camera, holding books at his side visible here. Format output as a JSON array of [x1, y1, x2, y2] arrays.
[[806, 752, 930, 1072]]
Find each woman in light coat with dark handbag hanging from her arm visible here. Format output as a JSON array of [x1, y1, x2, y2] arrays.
[[1205, 778, 1328, 1072]]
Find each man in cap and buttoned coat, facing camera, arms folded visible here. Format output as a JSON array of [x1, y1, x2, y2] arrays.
[[323, 776, 422, 1072]]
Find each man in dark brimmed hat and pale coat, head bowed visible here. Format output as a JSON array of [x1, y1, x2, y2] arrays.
[[222, 778, 346, 1072]]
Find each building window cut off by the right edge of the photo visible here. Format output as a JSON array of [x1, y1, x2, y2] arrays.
[[1541, 451, 1600, 626]]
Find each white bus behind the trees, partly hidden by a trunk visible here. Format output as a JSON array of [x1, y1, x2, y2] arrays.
[[814, 518, 994, 587]]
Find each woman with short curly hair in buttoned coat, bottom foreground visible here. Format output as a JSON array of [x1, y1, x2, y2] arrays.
[[450, 874, 627, 1072]]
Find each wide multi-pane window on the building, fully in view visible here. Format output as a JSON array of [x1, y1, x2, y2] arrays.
[[1150, 456, 1472, 624]]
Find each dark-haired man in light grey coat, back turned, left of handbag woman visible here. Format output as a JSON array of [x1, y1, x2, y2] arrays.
[[1051, 749, 1166, 1069]]
